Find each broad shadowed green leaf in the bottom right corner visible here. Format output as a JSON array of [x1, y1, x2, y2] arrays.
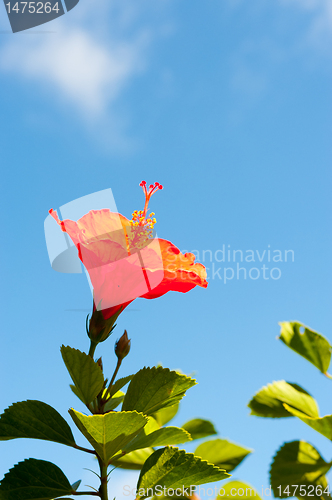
[[270, 441, 331, 499]]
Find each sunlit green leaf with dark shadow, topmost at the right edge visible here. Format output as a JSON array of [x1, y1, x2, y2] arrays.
[[279, 321, 332, 373]]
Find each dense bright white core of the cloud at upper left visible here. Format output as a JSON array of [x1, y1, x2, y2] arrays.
[[0, 15, 147, 117]]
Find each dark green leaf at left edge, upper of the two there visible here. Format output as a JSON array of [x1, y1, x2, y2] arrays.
[[0, 400, 76, 446]]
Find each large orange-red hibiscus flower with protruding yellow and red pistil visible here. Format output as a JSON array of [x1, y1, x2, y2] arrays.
[[49, 181, 207, 332]]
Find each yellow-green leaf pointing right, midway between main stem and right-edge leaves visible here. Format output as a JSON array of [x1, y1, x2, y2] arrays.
[[195, 439, 252, 472]]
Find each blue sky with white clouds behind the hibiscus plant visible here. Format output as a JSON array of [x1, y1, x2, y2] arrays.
[[0, 0, 332, 498]]
